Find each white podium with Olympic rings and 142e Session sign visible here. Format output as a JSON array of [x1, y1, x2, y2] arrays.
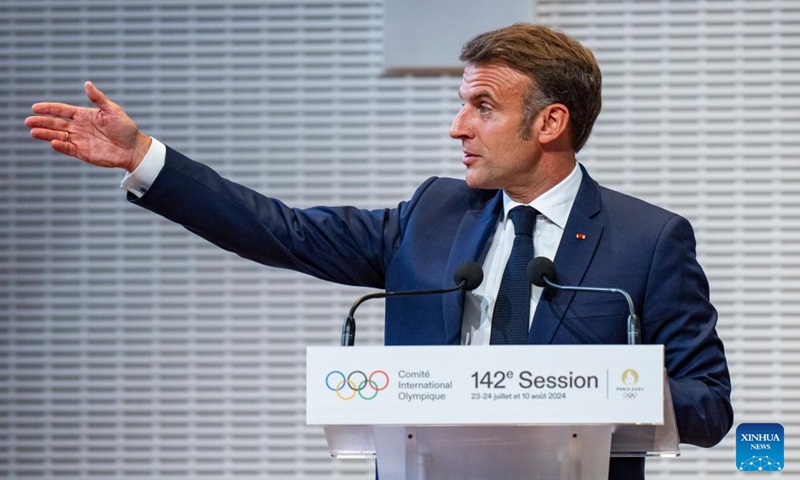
[[306, 345, 680, 480]]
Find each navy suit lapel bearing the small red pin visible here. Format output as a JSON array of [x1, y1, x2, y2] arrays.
[[528, 165, 603, 344]]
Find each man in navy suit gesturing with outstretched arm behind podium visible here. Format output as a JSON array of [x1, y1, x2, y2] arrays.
[[26, 24, 733, 480]]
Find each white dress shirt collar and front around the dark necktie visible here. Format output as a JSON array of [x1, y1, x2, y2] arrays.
[[461, 162, 583, 345]]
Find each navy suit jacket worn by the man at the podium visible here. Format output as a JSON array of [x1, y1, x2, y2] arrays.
[[132, 148, 733, 479]]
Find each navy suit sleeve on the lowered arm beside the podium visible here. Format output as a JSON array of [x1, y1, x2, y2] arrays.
[[642, 216, 733, 447]]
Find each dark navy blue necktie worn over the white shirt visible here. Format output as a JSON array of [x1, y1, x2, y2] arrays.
[[490, 205, 539, 345]]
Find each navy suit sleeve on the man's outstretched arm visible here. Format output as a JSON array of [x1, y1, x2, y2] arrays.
[[128, 147, 433, 288]]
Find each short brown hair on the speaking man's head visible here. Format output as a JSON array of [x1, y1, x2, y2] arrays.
[[460, 23, 602, 152]]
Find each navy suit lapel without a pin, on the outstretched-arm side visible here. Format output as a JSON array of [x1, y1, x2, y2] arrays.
[[442, 190, 503, 345]]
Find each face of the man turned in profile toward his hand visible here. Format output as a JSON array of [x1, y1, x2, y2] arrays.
[[450, 64, 541, 197]]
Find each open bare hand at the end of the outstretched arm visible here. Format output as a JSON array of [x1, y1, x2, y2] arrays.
[[25, 82, 151, 172]]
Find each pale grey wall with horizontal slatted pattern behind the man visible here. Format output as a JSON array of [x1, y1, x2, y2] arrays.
[[0, 0, 800, 479]]
